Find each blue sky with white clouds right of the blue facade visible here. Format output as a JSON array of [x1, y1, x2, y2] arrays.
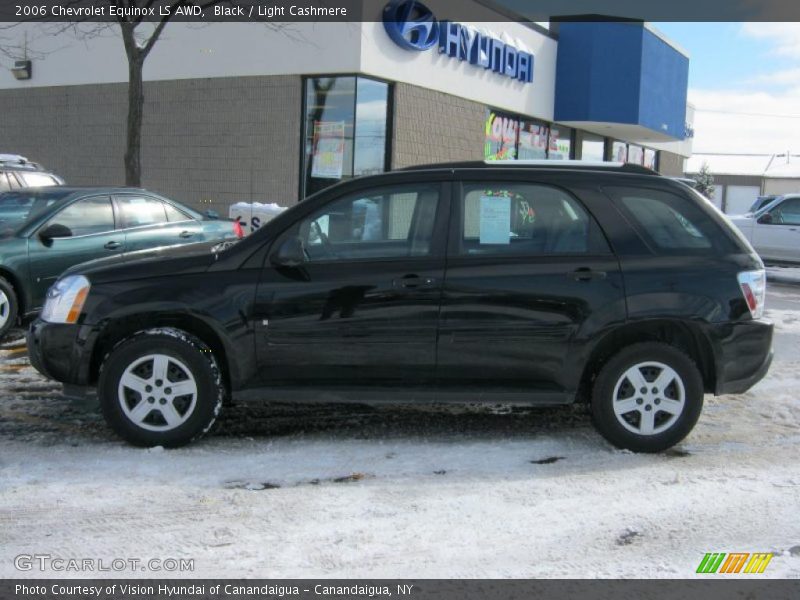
[[655, 23, 800, 154]]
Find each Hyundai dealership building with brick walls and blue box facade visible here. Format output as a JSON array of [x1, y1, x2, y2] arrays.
[[0, 0, 691, 214]]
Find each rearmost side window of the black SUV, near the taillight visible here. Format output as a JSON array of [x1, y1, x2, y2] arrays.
[[605, 187, 734, 254]]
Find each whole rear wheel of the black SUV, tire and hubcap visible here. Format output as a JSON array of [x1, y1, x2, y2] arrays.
[[592, 342, 703, 452]]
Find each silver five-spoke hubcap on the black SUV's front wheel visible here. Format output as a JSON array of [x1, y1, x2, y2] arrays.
[[118, 354, 197, 431]]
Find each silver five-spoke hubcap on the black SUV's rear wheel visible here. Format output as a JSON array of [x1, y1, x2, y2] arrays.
[[613, 362, 686, 435]]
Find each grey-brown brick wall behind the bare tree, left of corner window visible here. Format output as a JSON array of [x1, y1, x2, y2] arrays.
[[0, 76, 301, 216]]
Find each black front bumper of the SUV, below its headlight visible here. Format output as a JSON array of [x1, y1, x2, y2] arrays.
[[26, 319, 96, 387]]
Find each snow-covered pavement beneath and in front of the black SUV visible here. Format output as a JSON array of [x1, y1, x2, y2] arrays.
[[0, 288, 800, 578]]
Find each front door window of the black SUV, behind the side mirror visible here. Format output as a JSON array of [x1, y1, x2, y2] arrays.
[[289, 184, 439, 262]]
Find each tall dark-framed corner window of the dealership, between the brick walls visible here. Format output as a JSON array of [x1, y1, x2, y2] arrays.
[[302, 77, 389, 197]]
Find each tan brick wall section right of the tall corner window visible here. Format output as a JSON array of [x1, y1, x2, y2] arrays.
[[392, 83, 486, 169]]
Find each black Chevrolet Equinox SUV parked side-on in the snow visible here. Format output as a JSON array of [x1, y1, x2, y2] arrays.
[[28, 161, 772, 452]]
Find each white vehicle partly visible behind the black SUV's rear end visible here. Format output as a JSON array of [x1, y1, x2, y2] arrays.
[[730, 194, 800, 262]]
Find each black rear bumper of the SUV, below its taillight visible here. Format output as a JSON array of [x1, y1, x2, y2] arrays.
[[714, 319, 773, 396]]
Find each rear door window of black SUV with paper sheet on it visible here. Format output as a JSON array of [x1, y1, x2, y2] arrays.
[[459, 183, 608, 256]]
